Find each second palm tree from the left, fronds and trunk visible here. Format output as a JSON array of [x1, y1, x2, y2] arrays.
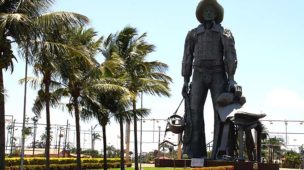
[[21, 24, 88, 169]]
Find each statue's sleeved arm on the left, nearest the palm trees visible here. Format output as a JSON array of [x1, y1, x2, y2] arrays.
[[182, 30, 194, 84]]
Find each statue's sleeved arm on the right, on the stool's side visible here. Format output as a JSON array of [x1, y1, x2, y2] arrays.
[[222, 29, 237, 82]]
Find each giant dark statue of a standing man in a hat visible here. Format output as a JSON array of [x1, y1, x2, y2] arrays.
[[182, 0, 241, 159]]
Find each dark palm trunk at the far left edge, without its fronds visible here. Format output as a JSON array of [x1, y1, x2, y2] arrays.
[[0, 68, 5, 170]]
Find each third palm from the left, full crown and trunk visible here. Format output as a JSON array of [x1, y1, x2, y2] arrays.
[[56, 28, 101, 169]]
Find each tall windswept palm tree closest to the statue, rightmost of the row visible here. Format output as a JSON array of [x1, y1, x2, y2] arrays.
[[111, 27, 172, 170]]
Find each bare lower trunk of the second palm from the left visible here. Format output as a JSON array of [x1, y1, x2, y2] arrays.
[[45, 83, 51, 170]]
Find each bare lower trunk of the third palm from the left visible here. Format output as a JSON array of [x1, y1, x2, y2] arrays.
[[74, 98, 81, 170]]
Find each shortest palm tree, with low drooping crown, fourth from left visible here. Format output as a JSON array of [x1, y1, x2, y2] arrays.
[[81, 66, 130, 169]]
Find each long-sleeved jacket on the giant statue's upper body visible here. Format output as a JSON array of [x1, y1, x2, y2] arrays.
[[182, 23, 237, 80]]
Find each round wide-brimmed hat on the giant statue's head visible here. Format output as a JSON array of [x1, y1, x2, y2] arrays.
[[196, 0, 224, 24]]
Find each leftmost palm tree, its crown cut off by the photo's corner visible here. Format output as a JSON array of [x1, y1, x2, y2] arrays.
[[0, 0, 88, 169]]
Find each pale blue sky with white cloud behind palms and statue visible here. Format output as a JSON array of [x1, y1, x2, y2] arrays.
[[4, 0, 304, 151]]
